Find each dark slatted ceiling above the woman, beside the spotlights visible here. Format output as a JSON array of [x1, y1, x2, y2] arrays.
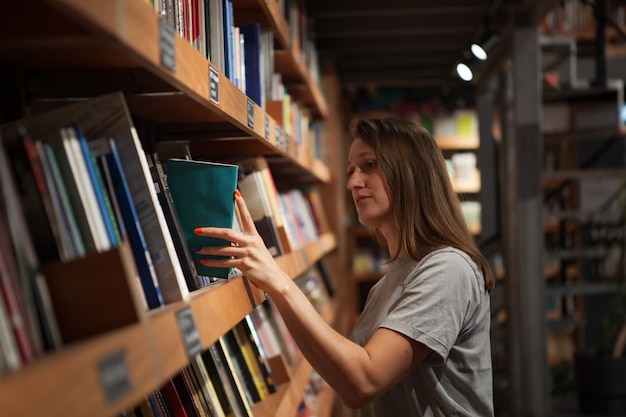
[[306, 0, 551, 101]]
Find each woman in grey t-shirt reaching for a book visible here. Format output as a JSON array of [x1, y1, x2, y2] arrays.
[[195, 118, 493, 417]]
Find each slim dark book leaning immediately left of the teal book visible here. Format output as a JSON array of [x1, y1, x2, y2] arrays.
[[148, 153, 202, 291]]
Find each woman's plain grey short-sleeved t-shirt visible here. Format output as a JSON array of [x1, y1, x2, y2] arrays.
[[351, 248, 493, 417]]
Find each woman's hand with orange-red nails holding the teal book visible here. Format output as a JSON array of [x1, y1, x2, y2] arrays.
[[195, 190, 289, 296]]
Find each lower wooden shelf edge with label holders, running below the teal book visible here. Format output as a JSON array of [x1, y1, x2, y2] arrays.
[[0, 235, 335, 417]]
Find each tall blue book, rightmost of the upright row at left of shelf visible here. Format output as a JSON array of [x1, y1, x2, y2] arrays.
[[106, 139, 164, 309]]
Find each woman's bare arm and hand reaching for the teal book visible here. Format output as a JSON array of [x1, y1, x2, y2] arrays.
[[197, 191, 430, 408]]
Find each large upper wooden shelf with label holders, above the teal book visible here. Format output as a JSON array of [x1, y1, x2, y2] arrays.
[[0, 0, 329, 182]]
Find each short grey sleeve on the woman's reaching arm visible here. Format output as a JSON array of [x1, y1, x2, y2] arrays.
[[380, 249, 477, 366]]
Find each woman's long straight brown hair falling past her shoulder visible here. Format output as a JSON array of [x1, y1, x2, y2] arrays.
[[351, 117, 495, 291]]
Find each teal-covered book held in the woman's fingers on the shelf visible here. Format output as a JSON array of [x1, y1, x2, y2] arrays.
[[166, 159, 239, 278]]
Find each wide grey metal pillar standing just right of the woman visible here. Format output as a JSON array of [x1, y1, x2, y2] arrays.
[[501, 27, 551, 417]]
